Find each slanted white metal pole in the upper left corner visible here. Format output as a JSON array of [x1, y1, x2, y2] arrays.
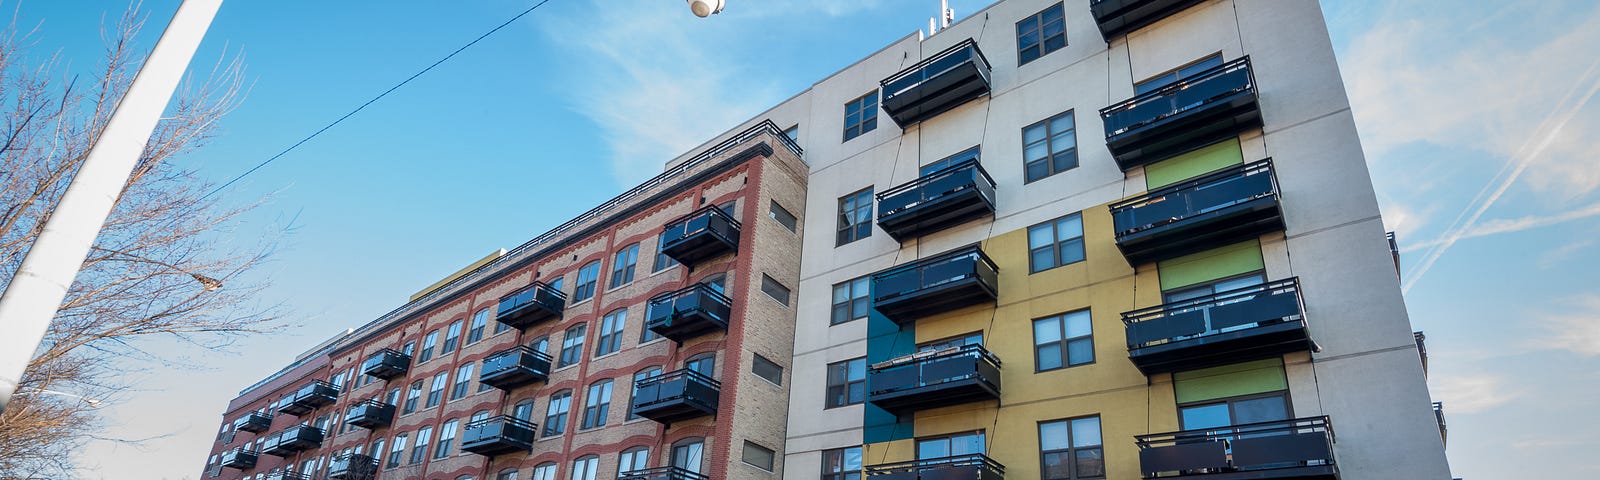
[[0, 0, 222, 411]]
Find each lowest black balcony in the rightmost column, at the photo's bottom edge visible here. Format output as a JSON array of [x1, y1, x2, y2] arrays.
[[1134, 416, 1339, 480]]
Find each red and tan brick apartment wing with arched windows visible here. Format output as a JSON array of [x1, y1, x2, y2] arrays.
[[205, 123, 806, 480]]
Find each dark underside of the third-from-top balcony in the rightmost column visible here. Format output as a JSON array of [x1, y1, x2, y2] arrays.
[[1117, 195, 1283, 266]]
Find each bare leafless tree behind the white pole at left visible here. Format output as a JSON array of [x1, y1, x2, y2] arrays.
[[0, 10, 274, 478]]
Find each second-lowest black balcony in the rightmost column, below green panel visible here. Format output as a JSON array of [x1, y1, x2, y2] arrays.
[[1122, 278, 1315, 374]]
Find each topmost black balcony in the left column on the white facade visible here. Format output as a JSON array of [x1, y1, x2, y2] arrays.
[[878, 38, 989, 128]]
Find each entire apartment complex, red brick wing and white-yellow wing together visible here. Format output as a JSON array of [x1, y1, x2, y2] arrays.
[[208, 0, 1450, 480]]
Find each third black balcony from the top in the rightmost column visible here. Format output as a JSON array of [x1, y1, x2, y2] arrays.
[[1110, 158, 1283, 266]]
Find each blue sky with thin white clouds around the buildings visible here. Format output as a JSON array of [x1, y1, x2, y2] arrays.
[[0, 0, 1600, 478]]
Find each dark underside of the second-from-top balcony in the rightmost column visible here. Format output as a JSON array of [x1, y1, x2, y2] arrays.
[[1106, 88, 1261, 171]]
